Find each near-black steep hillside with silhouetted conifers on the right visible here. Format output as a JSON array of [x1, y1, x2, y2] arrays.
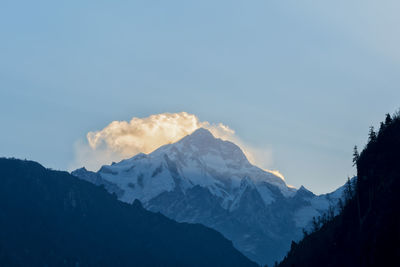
[[279, 114, 400, 267]]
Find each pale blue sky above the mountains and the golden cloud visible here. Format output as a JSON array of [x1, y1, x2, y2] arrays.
[[0, 0, 400, 193]]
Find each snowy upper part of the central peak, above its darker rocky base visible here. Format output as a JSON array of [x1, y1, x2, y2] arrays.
[[75, 128, 296, 209]]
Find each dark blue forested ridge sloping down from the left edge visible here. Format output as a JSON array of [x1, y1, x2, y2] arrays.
[[0, 158, 257, 266]]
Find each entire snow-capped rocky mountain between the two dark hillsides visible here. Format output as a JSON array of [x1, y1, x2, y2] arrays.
[[72, 129, 346, 264]]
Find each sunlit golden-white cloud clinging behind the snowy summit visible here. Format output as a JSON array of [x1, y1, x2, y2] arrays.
[[70, 112, 271, 178]]
